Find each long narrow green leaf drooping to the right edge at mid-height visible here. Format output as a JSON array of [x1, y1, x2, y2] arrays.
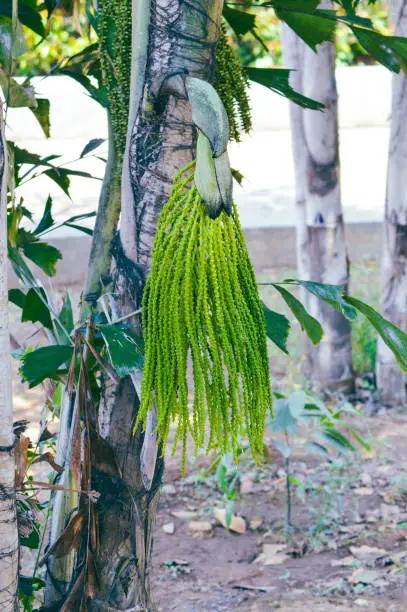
[[345, 297, 407, 372]]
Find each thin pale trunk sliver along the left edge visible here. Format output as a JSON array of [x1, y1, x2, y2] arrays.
[[0, 104, 18, 612]]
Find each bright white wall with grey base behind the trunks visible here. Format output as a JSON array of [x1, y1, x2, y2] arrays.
[[7, 66, 391, 286]]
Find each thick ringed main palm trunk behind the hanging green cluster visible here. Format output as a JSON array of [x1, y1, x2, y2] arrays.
[[91, 0, 223, 611]]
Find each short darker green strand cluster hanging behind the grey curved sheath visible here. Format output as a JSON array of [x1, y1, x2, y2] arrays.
[[213, 26, 252, 142]]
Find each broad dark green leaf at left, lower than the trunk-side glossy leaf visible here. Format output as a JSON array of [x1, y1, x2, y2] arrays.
[[20, 344, 73, 389]]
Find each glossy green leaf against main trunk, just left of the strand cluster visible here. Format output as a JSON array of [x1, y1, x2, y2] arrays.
[[99, 325, 144, 376]]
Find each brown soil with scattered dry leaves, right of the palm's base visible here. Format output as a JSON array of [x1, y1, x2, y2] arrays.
[[152, 412, 407, 612]]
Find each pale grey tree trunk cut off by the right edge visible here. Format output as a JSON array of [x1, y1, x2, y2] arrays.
[[376, 0, 407, 405]]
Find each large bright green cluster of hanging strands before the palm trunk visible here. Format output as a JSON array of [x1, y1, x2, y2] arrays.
[[138, 164, 272, 467]]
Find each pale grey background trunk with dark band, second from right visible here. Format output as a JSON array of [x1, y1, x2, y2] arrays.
[[283, 0, 353, 392]]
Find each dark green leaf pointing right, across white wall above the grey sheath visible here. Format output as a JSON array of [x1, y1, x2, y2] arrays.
[[245, 67, 325, 110]]
